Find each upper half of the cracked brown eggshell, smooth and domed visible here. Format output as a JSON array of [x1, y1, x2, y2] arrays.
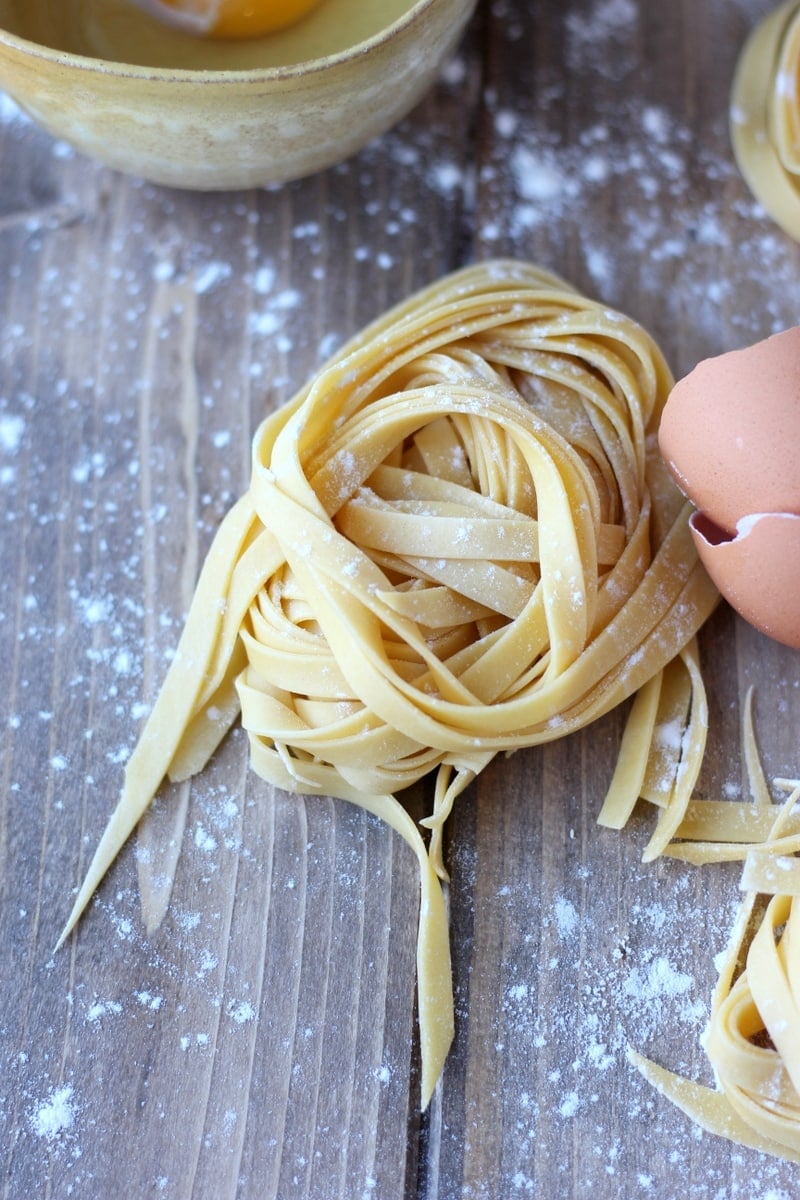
[[658, 328, 800, 535]]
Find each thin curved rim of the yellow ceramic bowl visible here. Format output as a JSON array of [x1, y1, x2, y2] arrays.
[[0, 0, 450, 84]]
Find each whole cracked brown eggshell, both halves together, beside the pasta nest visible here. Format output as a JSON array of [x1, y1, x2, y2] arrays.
[[658, 328, 800, 649]]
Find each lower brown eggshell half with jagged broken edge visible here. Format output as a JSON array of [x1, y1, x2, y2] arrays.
[[691, 512, 800, 649]]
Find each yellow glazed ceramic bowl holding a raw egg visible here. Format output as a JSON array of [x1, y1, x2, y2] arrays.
[[0, 0, 476, 188]]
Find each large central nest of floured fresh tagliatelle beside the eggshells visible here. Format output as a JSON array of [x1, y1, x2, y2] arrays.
[[59, 262, 717, 1103]]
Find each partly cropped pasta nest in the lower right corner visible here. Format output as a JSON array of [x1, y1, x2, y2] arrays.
[[630, 694, 800, 1163]]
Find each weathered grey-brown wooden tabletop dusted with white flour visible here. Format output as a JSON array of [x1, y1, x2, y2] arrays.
[[0, 0, 800, 1200]]
